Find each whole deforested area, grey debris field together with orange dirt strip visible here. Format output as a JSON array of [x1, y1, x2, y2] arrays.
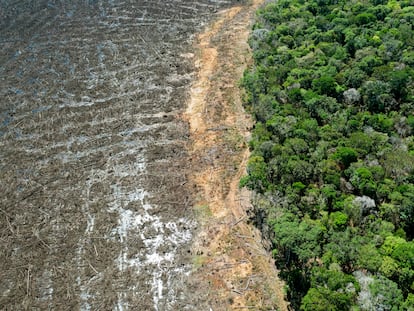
[[0, 0, 283, 311]]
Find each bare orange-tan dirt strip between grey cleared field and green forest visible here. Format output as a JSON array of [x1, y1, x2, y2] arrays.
[[185, 0, 288, 310]]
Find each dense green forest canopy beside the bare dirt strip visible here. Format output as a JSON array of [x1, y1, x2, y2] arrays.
[[240, 0, 414, 311]]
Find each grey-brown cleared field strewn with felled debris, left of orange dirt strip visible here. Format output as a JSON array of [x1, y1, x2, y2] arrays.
[[0, 0, 239, 310]]
